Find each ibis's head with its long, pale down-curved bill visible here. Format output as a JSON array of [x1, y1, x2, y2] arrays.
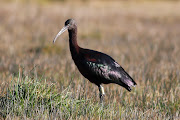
[[53, 19, 76, 43]]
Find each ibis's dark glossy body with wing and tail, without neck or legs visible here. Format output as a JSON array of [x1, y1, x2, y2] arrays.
[[73, 48, 136, 91]]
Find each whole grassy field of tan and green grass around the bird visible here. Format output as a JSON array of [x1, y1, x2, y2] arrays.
[[0, 1, 180, 120]]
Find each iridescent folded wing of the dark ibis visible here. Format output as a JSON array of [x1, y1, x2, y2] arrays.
[[82, 48, 136, 89]]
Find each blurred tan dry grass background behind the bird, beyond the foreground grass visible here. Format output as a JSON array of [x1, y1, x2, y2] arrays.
[[0, 0, 180, 119]]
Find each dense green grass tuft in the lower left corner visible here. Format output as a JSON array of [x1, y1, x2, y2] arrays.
[[0, 72, 87, 119]]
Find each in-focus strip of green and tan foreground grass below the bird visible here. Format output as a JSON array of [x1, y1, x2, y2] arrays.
[[0, 68, 179, 119]]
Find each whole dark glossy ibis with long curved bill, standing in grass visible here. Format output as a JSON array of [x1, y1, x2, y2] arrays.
[[53, 19, 137, 103]]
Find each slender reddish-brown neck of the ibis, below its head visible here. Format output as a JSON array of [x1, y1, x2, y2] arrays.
[[68, 28, 79, 56]]
